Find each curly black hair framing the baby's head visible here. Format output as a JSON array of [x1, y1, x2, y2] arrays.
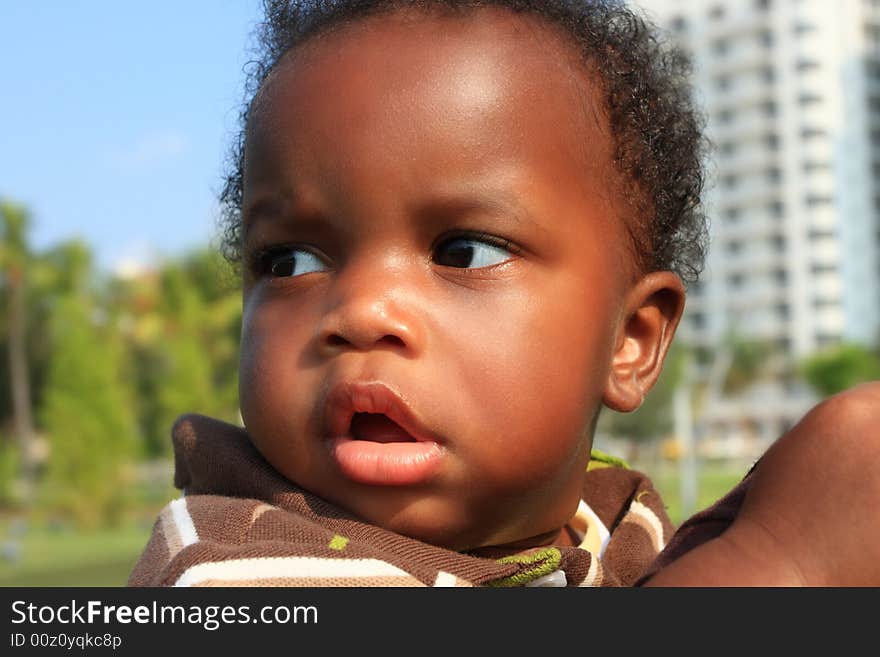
[[220, 0, 708, 284]]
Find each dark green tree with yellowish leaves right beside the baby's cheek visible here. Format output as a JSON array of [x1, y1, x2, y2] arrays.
[[113, 249, 241, 456]]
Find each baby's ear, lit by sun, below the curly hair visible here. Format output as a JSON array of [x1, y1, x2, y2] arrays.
[[603, 271, 685, 413]]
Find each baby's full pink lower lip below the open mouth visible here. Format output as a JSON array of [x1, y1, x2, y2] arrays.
[[330, 436, 444, 486]]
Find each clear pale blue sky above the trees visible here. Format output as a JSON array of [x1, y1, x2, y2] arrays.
[[0, 0, 258, 269]]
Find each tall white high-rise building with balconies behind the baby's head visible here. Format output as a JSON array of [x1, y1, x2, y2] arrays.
[[631, 0, 880, 440]]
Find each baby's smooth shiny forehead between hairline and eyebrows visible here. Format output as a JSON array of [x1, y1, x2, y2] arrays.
[[248, 10, 613, 192]]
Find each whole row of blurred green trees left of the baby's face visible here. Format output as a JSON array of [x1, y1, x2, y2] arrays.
[[0, 202, 241, 525]]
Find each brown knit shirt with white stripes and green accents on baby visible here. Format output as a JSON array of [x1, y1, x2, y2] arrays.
[[128, 415, 673, 587]]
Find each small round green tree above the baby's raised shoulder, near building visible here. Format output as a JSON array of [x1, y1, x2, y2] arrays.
[[801, 343, 880, 397]]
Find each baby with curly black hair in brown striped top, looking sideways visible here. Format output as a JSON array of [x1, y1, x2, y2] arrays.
[[130, 0, 880, 586]]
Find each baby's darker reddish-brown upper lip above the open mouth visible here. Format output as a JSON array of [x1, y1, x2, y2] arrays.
[[324, 381, 439, 442]]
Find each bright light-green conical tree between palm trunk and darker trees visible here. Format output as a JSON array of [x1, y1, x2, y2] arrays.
[[41, 249, 137, 526]]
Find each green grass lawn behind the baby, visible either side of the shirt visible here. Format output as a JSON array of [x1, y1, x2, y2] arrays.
[[0, 464, 745, 586]]
